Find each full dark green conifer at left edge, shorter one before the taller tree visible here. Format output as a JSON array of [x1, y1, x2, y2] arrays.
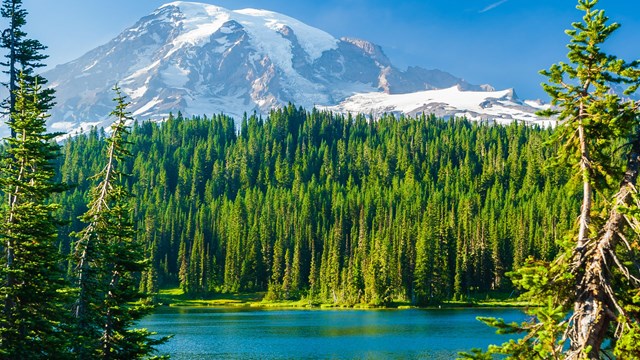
[[0, 81, 68, 359]]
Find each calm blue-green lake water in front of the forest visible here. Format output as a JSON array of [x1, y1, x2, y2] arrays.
[[140, 308, 525, 360]]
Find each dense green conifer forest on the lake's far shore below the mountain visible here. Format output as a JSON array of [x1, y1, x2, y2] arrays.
[[59, 105, 579, 304]]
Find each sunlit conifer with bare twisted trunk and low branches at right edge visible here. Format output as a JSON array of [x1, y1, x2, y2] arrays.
[[466, 0, 640, 359]]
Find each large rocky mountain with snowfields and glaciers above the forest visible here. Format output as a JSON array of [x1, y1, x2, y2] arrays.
[[20, 1, 548, 133]]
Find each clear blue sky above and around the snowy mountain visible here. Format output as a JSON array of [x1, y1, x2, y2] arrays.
[[22, 0, 640, 99]]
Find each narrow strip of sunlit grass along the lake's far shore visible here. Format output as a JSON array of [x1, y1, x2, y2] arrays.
[[156, 288, 531, 309]]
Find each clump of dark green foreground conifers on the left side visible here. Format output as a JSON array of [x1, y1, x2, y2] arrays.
[[0, 0, 166, 359]]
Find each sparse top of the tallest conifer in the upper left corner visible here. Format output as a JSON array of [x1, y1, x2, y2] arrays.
[[0, 0, 54, 136]]
